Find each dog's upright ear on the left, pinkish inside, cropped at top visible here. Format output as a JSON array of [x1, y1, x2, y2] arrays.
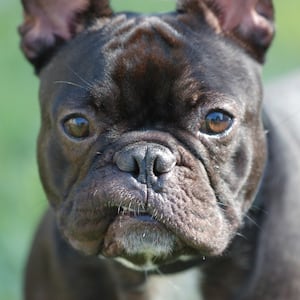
[[19, 0, 112, 71]]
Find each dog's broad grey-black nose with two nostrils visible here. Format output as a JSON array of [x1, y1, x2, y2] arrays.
[[114, 143, 176, 183]]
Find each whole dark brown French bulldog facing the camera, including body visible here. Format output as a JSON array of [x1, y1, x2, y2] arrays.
[[20, 0, 300, 300]]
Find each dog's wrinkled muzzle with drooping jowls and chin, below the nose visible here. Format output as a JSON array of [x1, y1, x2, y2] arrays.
[[58, 157, 240, 270]]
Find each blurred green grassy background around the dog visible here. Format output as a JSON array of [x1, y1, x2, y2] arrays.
[[0, 0, 300, 300]]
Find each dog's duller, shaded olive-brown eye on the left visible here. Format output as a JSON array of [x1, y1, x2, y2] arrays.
[[63, 116, 90, 139]]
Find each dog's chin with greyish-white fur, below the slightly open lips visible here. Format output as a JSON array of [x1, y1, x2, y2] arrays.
[[101, 215, 182, 271]]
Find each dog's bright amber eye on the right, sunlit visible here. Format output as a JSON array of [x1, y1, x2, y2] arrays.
[[203, 111, 233, 135]]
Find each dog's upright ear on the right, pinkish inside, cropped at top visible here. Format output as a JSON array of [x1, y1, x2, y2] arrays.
[[177, 0, 275, 63]]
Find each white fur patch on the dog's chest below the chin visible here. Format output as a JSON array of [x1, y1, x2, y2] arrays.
[[147, 268, 204, 300]]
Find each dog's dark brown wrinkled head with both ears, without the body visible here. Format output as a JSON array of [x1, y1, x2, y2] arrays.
[[20, 0, 273, 268]]
